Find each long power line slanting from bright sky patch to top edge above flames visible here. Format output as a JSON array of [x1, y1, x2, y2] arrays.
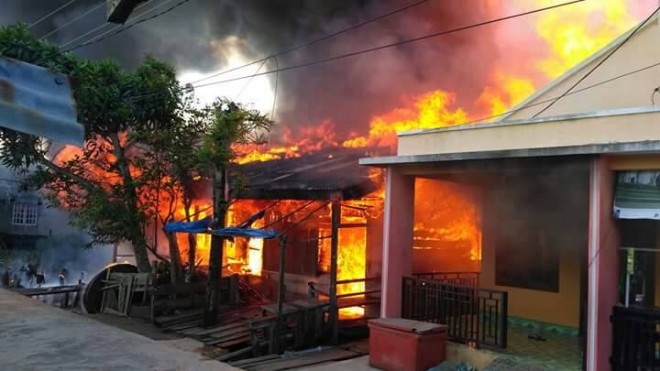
[[193, 0, 585, 88]]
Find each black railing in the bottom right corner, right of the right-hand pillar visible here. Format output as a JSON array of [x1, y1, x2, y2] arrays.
[[610, 306, 660, 371]]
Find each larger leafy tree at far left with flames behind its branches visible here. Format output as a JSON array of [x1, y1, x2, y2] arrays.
[[0, 25, 183, 272]]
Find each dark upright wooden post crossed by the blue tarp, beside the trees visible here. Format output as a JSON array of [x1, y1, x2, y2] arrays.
[[202, 169, 229, 327]]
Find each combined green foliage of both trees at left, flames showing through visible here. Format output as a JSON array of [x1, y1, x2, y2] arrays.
[[0, 25, 272, 270]]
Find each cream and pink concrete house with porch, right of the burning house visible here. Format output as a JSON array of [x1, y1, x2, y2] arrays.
[[361, 18, 660, 370]]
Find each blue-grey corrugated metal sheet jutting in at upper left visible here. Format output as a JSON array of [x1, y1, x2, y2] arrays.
[[0, 57, 84, 146]]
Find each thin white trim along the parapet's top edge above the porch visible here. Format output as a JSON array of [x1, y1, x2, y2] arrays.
[[397, 106, 660, 137]]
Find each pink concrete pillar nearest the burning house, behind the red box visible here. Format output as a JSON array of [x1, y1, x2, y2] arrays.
[[380, 167, 415, 317]]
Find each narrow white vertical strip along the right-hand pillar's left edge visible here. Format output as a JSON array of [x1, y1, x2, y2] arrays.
[[587, 158, 601, 371]]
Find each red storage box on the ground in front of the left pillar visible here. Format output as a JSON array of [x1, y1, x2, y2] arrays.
[[369, 318, 447, 371]]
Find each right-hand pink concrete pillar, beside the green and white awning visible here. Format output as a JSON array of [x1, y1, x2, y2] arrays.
[[587, 157, 619, 371]]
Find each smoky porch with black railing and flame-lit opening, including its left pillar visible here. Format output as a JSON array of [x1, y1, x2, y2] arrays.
[[372, 158, 590, 369]]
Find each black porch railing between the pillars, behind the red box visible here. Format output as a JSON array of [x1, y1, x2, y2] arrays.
[[401, 277, 508, 349]]
